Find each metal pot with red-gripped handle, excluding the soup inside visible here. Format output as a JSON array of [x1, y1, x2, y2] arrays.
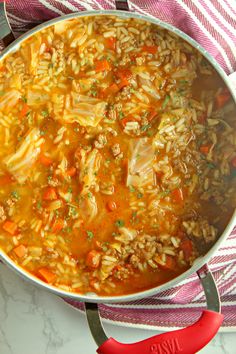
[[0, 0, 236, 354]]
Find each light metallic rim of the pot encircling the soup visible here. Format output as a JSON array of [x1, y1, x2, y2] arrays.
[[0, 10, 236, 303]]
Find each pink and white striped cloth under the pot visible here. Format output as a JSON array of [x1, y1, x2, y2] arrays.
[[1, 0, 236, 330]]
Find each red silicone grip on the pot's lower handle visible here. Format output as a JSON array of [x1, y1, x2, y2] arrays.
[[97, 310, 223, 354]]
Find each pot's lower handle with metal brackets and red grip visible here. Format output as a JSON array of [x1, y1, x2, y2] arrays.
[[85, 265, 223, 354]]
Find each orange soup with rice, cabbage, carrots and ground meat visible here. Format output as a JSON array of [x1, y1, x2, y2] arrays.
[[0, 16, 236, 296]]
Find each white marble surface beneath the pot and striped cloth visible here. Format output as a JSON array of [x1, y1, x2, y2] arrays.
[[0, 265, 236, 354]]
